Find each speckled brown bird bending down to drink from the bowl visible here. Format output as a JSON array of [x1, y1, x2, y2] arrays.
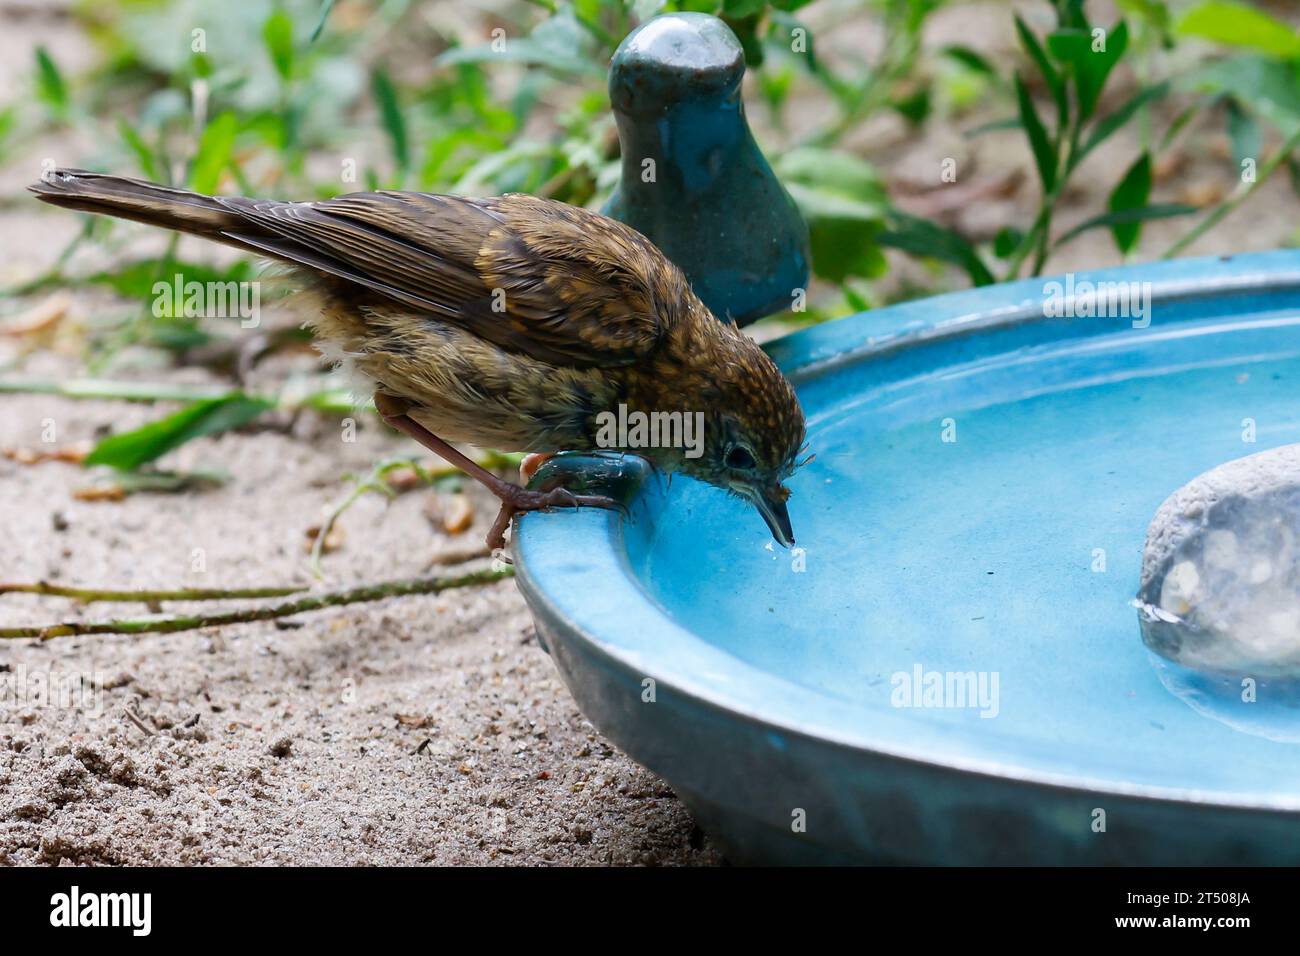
[[29, 169, 803, 549]]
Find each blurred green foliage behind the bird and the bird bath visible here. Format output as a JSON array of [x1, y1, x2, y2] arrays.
[[0, 0, 1300, 478]]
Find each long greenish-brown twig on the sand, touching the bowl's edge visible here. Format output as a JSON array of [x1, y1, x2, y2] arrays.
[[0, 568, 514, 641]]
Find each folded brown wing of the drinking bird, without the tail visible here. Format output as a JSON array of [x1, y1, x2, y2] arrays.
[[218, 191, 689, 367]]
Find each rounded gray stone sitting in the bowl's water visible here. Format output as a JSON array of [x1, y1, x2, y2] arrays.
[[1136, 445, 1300, 679]]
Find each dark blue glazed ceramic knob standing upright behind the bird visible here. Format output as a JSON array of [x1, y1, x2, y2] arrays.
[[603, 13, 810, 325]]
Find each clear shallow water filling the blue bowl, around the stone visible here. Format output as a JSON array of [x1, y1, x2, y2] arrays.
[[629, 306, 1300, 795]]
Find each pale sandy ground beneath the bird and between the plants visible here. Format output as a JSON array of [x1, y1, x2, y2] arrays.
[[0, 4, 1296, 865]]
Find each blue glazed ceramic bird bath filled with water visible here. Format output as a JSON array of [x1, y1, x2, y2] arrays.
[[516, 251, 1300, 864]]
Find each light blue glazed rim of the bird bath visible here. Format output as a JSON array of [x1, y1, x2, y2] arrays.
[[515, 250, 1300, 813]]
